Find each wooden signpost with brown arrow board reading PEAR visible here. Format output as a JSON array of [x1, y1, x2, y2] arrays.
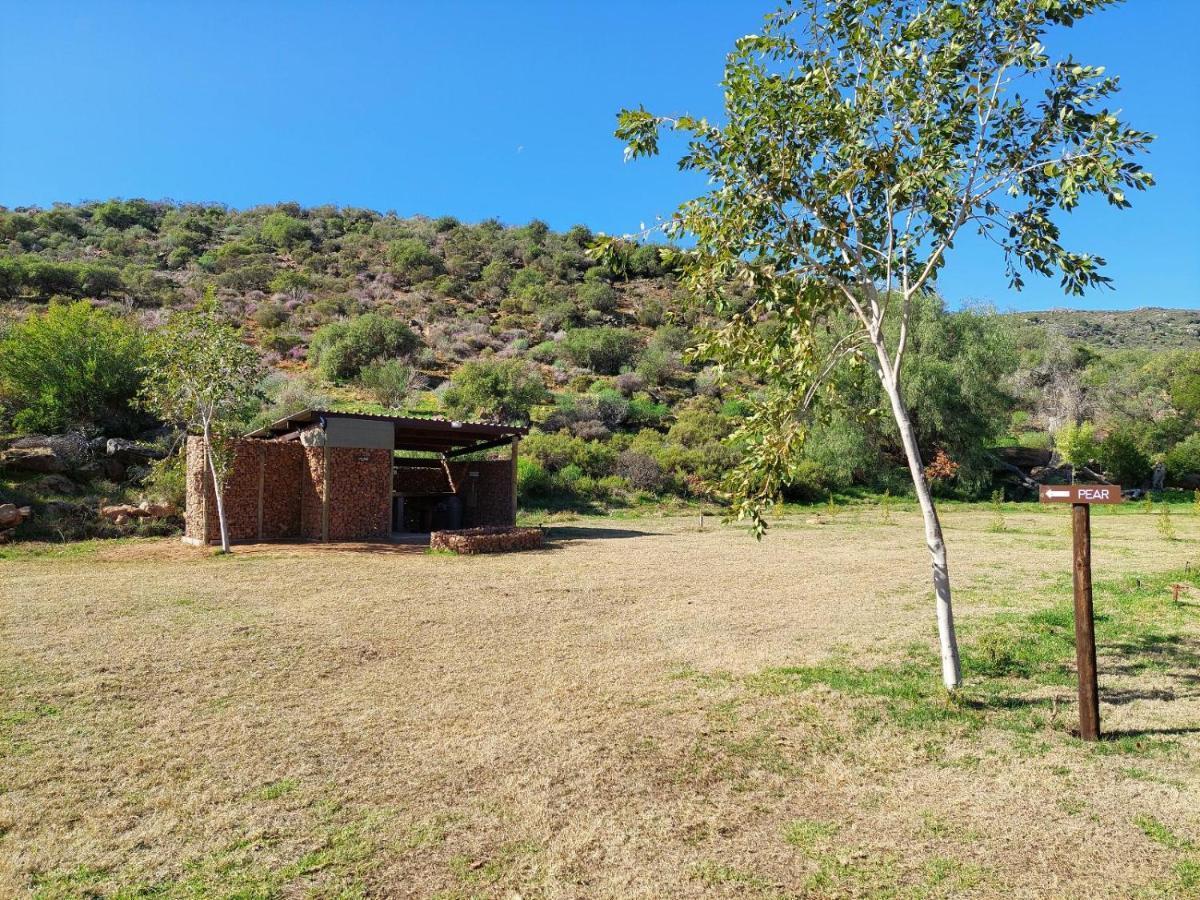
[[1038, 485, 1122, 740]]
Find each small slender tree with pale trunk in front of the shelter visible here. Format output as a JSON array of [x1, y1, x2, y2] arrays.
[[142, 292, 263, 553]]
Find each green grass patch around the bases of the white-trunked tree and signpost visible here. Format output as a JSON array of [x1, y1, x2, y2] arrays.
[[672, 571, 1200, 756]]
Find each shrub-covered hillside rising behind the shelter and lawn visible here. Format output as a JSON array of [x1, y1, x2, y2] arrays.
[[0, 199, 1200, 542]]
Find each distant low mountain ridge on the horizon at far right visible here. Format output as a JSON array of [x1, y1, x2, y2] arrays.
[[1007, 306, 1200, 350]]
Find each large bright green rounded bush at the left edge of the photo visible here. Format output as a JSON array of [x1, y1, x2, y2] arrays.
[[0, 301, 143, 432]]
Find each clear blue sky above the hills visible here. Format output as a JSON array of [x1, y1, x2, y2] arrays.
[[0, 0, 1200, 308]]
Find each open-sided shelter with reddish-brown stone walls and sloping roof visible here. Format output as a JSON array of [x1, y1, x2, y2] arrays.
[[184, 409, 528, 544]]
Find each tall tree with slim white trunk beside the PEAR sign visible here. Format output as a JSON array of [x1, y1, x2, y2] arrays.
[[609, 0, 1153, 689]]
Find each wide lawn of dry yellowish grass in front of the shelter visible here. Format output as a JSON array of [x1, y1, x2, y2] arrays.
[[0, 509, 1200, 898]]
